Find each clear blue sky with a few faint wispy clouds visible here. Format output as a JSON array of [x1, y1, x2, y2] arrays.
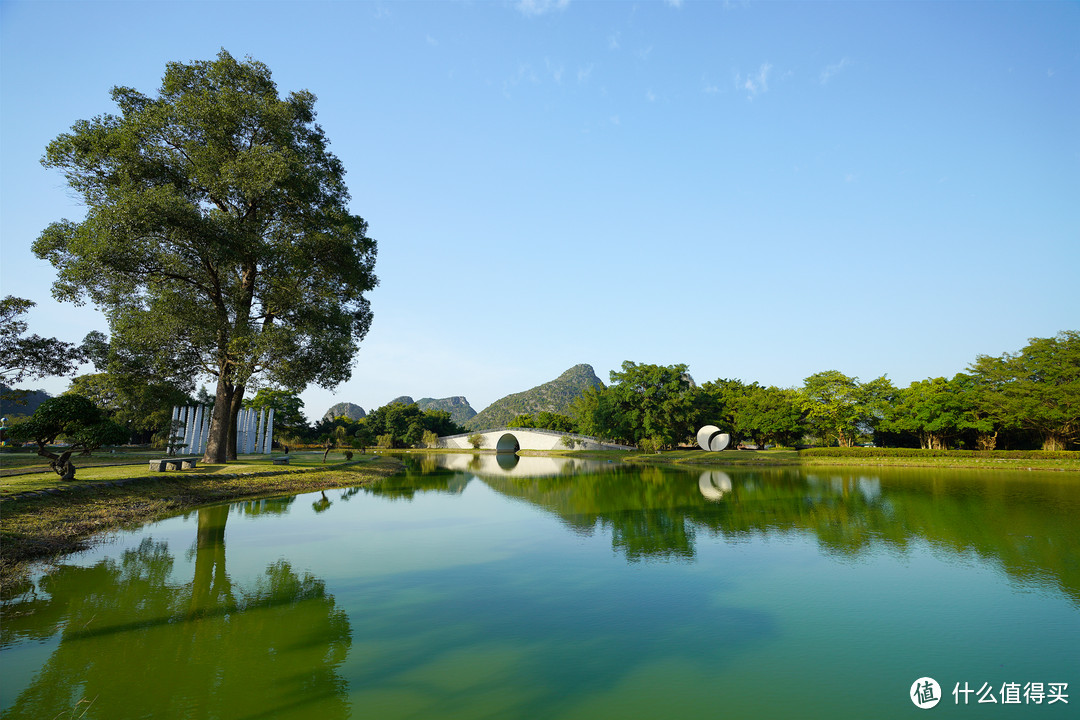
[[0, 0, 1080, 418]]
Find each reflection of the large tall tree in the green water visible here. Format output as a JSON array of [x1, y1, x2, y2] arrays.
[[3, 506, 350, 718]]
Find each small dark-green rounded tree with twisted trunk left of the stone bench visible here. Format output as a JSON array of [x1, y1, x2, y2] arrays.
[[10, 395, 127, 480]]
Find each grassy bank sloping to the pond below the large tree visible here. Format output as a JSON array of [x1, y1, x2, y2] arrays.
[[0, 454, 403, 597]]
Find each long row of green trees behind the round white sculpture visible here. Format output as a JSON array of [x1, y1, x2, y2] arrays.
[[503, 330, 1080, 450]]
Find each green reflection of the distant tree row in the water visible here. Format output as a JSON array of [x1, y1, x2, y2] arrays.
[[484, 468, 1080, 600]]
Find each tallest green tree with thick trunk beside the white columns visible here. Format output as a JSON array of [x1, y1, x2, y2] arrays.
[[33, 50, 376, 462]]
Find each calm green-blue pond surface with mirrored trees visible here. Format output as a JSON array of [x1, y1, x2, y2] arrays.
[[0, 456, 1080, 720]]
